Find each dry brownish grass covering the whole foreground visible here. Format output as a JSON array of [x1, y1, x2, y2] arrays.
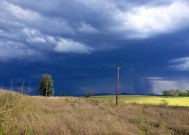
[[0, 92, 189, 135]]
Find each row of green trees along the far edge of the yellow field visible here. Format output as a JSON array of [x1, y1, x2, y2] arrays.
[[162, 89, 189, 97]]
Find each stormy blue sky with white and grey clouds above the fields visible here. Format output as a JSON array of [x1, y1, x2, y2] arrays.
[[0, 0, 189, 95]]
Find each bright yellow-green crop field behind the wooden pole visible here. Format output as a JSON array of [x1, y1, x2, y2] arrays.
[[91, 95, 189, 106]]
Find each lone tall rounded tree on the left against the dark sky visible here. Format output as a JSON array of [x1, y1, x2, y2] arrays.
[[39, 74, 54, 96]]
